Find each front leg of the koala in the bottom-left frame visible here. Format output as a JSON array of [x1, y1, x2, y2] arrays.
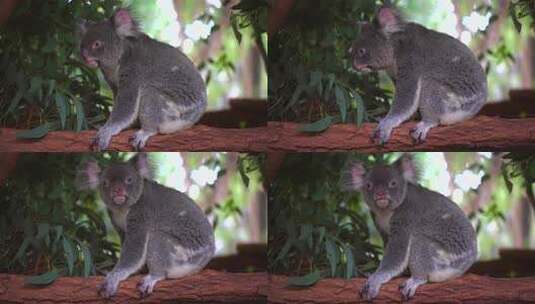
[[99, 222, 149, 298]]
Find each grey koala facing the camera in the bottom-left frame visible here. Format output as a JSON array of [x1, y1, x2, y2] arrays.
[[77, 154, 215, 298]]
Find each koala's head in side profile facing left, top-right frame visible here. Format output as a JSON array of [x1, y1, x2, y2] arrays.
[[349, 6, 405, 72]]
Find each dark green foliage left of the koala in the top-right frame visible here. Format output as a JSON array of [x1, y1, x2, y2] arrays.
[[269, 0, 391, 128]]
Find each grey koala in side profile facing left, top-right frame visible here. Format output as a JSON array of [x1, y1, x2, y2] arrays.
[[349, 6, 487, 144]]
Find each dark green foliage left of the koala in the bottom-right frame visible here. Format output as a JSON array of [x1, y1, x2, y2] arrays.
[[268, 153, 380, 286]]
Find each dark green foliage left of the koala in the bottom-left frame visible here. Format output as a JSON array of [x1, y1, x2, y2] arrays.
[[0, 153, 119, 285]]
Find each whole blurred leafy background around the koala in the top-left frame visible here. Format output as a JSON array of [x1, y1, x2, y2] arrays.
[[0, 0, 267, 138]]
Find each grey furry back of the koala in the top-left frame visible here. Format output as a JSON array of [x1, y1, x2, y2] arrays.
[[119, 35, 207, 104]]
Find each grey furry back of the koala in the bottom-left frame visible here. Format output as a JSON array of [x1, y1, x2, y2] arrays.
[[135, 180, 214, 250]]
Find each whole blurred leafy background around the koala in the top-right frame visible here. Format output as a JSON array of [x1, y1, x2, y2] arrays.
[[269, 0, 535, 128]]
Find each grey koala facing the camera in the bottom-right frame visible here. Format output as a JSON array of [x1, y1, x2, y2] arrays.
[[342, 155, 477, 300]]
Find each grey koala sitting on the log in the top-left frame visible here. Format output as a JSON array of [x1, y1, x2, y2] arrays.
[[79, 9, 207, 150]]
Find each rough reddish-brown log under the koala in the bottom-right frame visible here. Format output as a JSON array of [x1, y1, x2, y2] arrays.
[[268, 274, 535, 304]]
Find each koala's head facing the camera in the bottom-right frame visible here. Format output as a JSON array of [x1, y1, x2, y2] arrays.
[[341, 155, 418, 211]]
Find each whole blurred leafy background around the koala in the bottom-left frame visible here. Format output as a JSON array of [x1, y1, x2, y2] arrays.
[[0, 152, 267, 281]]
